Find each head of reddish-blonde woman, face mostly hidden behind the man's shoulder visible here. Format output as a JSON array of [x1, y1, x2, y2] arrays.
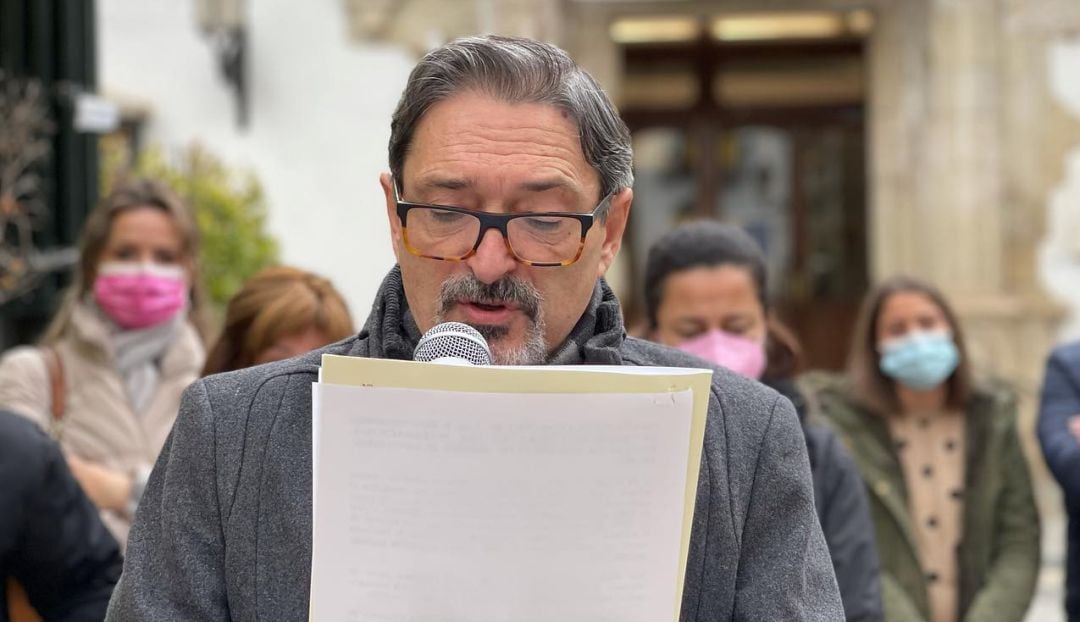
[[203, 266, 354, 376]]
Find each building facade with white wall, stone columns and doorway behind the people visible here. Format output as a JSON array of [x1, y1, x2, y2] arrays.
[[98, 0, 1080, 539]]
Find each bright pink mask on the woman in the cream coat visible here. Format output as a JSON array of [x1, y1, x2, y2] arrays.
[[94, 261, 188, 329]]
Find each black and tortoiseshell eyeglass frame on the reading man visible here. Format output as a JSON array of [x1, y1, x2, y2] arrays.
[[390, 178, 616, 268]]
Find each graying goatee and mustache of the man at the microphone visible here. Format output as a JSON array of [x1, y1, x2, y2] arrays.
[[435, 274, 548, 365]]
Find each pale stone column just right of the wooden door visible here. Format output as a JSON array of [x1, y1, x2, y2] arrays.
[[868, 0, 1003, 296]]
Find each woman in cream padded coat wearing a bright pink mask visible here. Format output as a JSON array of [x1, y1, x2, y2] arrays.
[[0, 180, 205, 545]]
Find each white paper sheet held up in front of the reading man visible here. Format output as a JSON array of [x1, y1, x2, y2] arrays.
[[311, 384, 692, 622]]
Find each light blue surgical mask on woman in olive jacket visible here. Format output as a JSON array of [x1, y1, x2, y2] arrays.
[[878, 330, 960, 391]]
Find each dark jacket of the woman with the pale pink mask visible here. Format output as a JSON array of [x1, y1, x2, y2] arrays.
[[765, 378, 885, 622]]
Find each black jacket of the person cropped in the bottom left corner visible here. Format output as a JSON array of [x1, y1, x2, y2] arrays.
[[0, 411, 122, 622]]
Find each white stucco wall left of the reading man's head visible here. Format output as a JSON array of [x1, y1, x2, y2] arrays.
[[97, 0, 415, 324]]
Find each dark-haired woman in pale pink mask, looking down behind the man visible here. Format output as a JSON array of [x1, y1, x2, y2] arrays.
[[645, 220, 883, 621]]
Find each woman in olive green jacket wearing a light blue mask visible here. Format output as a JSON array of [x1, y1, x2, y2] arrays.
[[802, 279, 1039, 622]]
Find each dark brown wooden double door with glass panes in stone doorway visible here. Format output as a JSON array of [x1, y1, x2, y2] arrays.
[[621, 40, 868, 369]]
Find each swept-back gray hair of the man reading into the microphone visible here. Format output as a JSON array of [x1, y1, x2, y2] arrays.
[[390, 36, 634, 197]]
